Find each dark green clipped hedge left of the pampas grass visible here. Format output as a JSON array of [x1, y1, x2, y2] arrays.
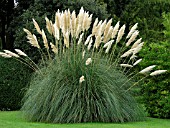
[[0, 57, 31, 110]]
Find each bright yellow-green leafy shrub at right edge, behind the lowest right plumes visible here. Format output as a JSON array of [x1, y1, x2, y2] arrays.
[[141, 14, 170, 118]]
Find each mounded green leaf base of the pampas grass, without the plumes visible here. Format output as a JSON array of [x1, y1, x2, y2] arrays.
[[22, 49, 144, 123]]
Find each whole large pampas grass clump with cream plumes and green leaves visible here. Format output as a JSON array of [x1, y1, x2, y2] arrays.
[[0, 8, 166, 123]]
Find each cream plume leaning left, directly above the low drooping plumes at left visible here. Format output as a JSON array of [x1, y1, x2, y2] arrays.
[[23, 28, 40, 48]]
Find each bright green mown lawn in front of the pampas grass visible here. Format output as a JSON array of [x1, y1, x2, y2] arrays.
[[0, 112, 170, 128]]
